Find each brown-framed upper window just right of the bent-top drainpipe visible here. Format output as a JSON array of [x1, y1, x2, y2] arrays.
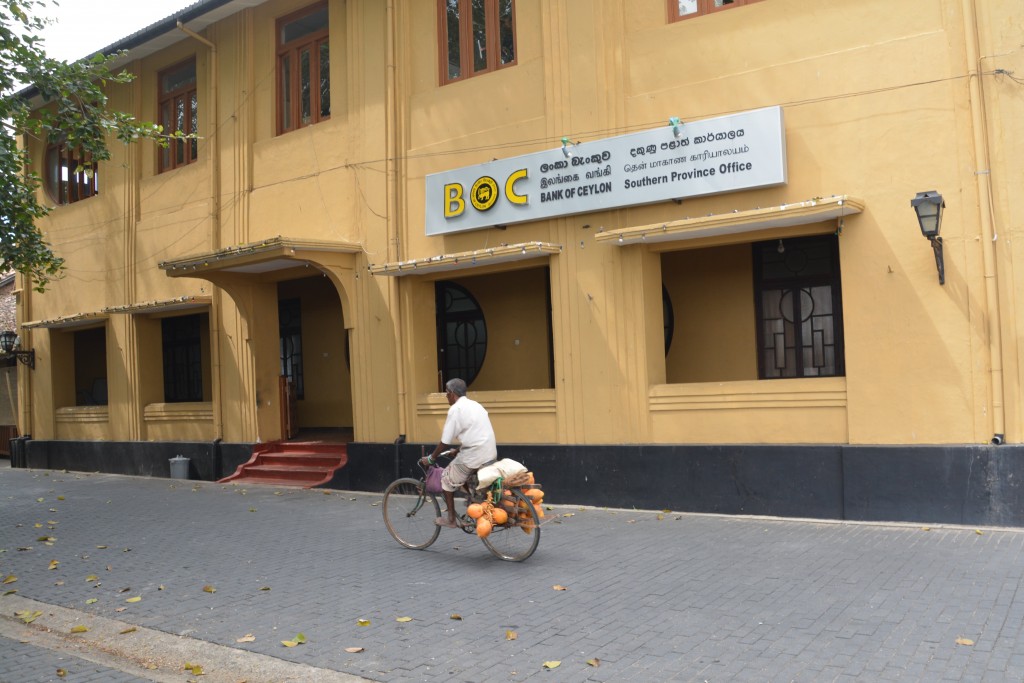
[[278, 2, 331, 135]]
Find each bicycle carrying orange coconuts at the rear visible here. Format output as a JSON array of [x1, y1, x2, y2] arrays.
[[382, 451, 544, 562]]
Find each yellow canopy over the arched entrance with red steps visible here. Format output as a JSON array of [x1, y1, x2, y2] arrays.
[[160, 237, 362, 278]]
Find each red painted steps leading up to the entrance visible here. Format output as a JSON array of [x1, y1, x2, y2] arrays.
[[218, 441, 348, 488]]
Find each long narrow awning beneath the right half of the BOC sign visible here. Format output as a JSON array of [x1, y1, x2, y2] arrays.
[[594, 195, 864, 246]]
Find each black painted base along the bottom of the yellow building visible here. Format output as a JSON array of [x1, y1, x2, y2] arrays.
[[11, 439, 1024, 526]]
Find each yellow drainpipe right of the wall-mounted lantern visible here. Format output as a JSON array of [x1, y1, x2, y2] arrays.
[[963, 0, 1006, 445]]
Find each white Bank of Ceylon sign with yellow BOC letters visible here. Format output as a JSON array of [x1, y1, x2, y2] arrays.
[[426, 106, 786, 234]]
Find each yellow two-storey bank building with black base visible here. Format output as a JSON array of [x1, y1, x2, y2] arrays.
[[18, 0, 1024, 524]]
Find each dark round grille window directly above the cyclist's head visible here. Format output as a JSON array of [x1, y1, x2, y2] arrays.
[[434, 280, 487, 386]]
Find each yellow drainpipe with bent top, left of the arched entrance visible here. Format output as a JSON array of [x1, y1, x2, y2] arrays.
[[177, 22, 224, 440]]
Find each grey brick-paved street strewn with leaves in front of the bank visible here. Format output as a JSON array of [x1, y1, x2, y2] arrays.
[[0, 467, 1024, 683]]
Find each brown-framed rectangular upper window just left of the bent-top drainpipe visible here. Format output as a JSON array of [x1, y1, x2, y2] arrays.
[[158, 57, 199, 173]]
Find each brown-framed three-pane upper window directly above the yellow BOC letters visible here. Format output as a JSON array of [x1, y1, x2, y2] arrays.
[[437, 0, 516, 85]]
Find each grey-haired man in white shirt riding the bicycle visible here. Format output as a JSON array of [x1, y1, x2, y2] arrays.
[[420, 379, 498, 528]]
